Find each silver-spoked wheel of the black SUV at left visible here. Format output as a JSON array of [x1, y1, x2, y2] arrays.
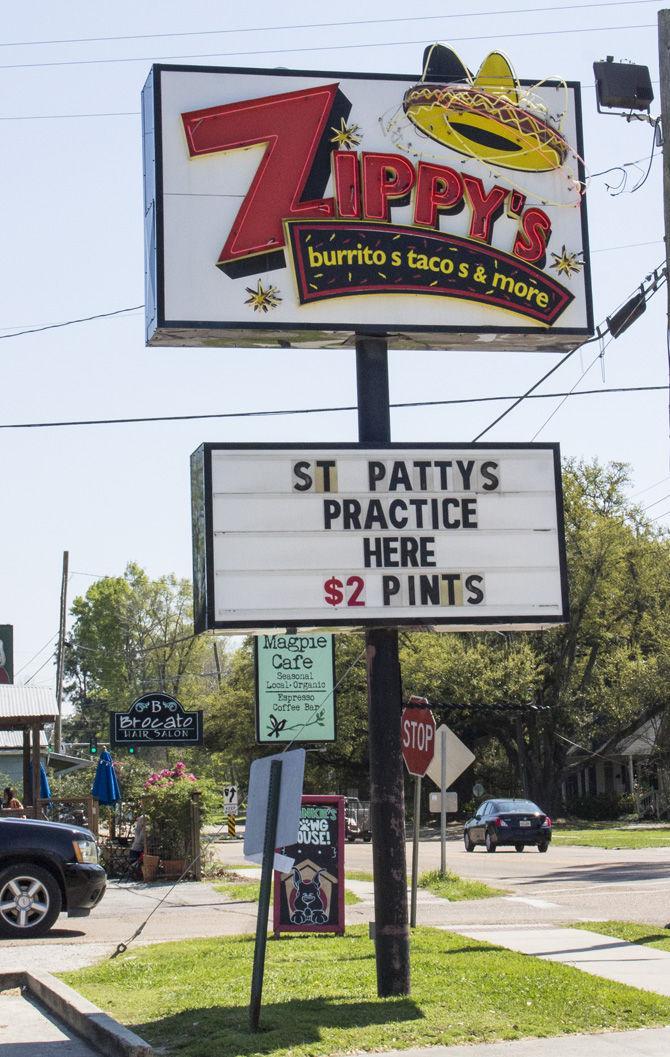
[[0, 863, 62, 940]]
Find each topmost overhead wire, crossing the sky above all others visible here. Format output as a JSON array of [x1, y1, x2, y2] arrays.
[[0, 0, 655, 48]]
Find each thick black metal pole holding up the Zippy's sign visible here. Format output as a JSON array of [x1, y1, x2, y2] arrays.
[[356, 337, 410, 998]]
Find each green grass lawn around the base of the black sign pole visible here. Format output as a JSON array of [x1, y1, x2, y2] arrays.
[[61, 927, 670, 1057]]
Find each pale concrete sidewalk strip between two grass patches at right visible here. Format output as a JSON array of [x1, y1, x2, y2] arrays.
[[440, 925, 670, 997]]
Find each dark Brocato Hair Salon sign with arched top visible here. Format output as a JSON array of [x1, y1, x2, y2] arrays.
[[110, 692, 203, 746]]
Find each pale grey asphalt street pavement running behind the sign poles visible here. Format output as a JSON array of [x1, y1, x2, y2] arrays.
[[0, 839, 670, 971]]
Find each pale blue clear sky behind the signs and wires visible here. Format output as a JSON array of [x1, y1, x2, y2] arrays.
[[0, 0, 670, 685]]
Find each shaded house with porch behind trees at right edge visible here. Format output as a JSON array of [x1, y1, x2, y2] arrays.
[[562, 706, 670, 818]]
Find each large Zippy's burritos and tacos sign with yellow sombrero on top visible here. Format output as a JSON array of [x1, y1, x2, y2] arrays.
[[143, 59, 593, 350]]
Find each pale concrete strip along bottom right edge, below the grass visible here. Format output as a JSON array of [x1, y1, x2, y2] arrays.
[[350, 1027, 670, 1057]]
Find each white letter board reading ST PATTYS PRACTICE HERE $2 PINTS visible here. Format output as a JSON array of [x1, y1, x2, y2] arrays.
[[191, 444, 567, 632]]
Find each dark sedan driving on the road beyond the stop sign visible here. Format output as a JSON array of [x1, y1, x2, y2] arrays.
[[463, 799, 552, 852]]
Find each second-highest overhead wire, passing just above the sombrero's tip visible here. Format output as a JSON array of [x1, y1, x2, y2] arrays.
[[0, 22, 656, 70]]
